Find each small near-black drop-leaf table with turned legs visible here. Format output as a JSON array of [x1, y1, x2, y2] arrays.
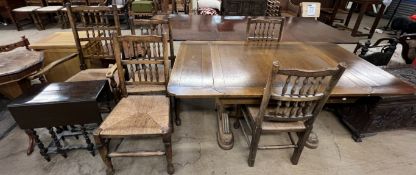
[[8, 80, 112, 161]]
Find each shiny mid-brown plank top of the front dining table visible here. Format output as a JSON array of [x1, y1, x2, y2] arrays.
[[168, 41, 416, 98]]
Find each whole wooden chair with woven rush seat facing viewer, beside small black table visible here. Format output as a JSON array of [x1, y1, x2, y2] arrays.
[[94, 34, 174, 174]]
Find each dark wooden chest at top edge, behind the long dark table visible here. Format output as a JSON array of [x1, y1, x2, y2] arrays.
[[222, 0, 267, 16]]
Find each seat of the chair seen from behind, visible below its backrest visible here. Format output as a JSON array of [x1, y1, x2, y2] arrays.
[[247, 106, 306, 132]]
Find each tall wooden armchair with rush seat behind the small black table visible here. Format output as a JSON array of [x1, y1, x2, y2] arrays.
[[31, 4, 121, 98]]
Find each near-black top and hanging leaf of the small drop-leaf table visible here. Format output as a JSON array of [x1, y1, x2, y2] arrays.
[[8, 80, 111, 129]]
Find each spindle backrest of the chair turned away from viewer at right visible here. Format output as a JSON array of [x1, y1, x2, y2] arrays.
[[258, 62, 346, 124]]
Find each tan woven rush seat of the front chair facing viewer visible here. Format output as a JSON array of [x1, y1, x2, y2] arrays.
[[99, 95, 169, 137]]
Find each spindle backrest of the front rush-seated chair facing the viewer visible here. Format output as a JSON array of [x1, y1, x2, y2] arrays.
[[113, 33, 170, 96]]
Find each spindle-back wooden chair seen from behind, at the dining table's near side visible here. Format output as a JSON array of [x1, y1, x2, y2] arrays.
[[235, 62, 346, 166]]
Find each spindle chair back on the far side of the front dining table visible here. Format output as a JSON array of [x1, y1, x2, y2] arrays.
[[246, 17, 285, 44]]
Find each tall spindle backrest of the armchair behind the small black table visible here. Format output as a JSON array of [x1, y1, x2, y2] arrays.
[[66, 4, 121, 69]]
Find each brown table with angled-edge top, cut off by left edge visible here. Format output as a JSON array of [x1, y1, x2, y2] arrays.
[[0, 48, 43, 99]]
